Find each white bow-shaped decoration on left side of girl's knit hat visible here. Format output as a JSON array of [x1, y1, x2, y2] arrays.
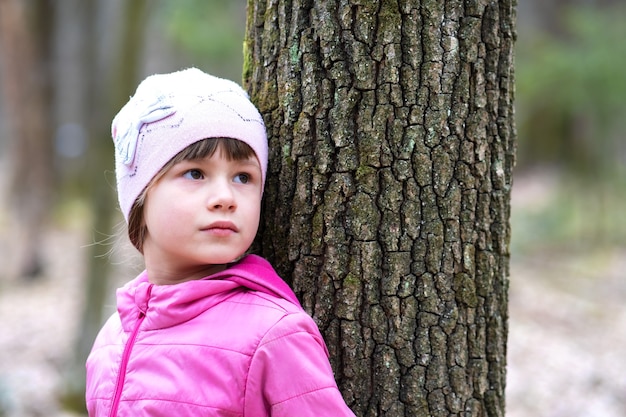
[[113, 94, 176, 166]]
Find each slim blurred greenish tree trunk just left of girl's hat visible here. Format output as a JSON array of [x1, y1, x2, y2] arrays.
[[63, 0, 147, 412]]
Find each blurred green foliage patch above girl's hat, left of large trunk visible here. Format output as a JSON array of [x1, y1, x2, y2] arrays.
[[159, 0, 247, 82]]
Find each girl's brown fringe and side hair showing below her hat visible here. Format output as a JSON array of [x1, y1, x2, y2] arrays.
[[128, 138, 256, 253]]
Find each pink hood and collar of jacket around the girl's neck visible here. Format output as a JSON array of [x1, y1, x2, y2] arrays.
[[117, 255, 302, 331]]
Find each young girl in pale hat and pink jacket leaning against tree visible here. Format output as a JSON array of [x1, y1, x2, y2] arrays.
[[86, 68, 354, 417]]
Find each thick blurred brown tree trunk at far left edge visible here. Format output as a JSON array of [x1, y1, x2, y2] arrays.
[[0, 0, 54, 278]]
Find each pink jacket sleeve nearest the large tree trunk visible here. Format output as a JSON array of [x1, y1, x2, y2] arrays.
[[244, 312, 354, 417]]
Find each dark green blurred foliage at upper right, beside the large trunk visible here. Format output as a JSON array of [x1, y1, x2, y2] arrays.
[[516, 4, 626, 179]]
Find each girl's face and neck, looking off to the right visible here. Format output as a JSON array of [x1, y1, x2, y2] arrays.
[[143, 145, 262, 284]]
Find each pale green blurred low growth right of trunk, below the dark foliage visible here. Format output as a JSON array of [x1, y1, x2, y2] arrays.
[[511, 172, 626, 254]]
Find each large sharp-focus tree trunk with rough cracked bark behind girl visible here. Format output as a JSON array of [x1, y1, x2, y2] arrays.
[[244, 0, 515, 416]]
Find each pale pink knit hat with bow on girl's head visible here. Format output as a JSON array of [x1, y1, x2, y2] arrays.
[[111, 68, 268, 222]]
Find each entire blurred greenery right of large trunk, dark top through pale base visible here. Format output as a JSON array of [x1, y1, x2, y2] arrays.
[[511, 4, 626, 253]]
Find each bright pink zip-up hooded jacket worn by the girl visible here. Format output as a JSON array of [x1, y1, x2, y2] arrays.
[[86, 255, 354, 417]]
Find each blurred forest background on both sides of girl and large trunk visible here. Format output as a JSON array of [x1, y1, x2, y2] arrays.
[[0, 0, 626, 417]]
